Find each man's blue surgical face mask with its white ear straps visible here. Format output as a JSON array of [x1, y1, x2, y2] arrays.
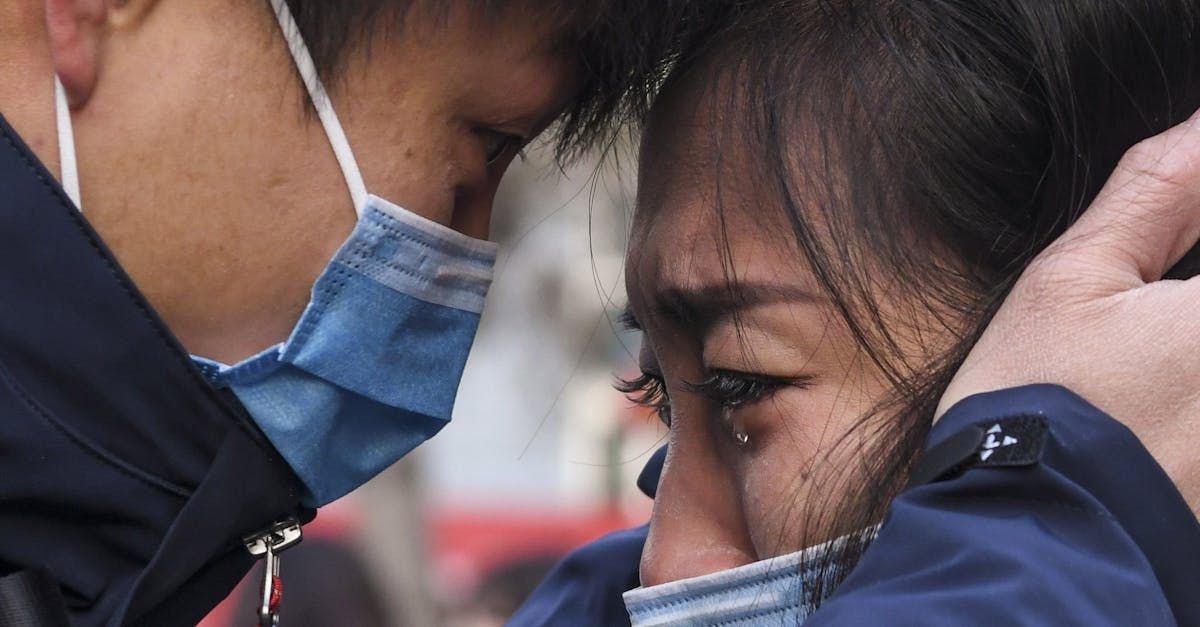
[[58, 0, 497, 506]]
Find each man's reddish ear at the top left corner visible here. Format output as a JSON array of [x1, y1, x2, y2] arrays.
[[46, 0, 109, 107]]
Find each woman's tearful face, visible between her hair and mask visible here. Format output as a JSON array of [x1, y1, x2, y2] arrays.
[[625, 73, 902, 586]]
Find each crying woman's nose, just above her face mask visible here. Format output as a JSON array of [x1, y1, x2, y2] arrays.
[[641, 440, 757, 586]]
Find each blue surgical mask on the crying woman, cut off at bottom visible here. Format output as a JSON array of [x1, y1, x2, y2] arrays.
[[624, 527, 876, 627]]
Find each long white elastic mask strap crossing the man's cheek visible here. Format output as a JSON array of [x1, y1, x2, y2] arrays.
[[271, 0, 367, 215]]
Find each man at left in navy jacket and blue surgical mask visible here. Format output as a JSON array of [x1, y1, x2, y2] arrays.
[[0, 0, 720, 626]]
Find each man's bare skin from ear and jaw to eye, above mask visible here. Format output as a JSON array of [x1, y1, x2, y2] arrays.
[[0, 0, 575, 363]]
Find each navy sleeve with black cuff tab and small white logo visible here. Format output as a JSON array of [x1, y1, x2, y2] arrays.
[[805, 386, 1200, 627]]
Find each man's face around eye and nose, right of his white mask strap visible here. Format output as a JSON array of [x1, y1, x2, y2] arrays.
[[321, 1, 583, 238]]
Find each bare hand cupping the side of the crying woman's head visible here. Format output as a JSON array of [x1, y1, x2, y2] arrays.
[[937, 112, 1200, 512]]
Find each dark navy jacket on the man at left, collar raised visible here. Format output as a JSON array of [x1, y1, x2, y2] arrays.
[[0, 112, 312, 626]]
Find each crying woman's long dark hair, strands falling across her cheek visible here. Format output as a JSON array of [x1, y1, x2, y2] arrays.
[[668, 0, 1200, 603]]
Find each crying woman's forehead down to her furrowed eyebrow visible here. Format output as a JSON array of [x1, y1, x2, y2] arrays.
[[626, 70, 835, 317]]
